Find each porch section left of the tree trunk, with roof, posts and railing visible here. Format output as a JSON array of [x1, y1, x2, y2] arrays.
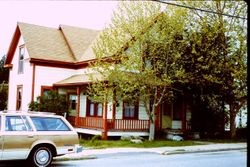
[[53, 74, 149, 139]]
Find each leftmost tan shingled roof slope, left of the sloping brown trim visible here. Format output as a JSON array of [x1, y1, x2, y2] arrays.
[[18, 23, 75, 62]]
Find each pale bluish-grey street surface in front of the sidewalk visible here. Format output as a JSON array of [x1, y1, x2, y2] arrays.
[[52, 150, 247, 167]]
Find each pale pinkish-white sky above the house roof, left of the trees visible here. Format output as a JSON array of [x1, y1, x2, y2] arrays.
[[0, 0, 118, 58]]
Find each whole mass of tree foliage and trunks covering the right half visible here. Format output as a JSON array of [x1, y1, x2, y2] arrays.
[[89, 1, 247, 139]]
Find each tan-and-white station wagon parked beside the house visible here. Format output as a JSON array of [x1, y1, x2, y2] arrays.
[[0, 111, 82, 167]]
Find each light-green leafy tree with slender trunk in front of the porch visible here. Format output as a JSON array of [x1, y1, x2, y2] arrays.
[[89, 1, 186, 140]]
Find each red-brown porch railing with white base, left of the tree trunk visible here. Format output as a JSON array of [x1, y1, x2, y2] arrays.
[[67, 116, 149, 136]]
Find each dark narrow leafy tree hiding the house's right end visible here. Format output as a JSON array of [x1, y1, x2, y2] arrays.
[[181, 20, 230, 136]]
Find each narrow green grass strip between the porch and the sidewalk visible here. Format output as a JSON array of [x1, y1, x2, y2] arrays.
[[80, 139, 205, 148]]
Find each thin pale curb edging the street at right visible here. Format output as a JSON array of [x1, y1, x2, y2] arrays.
[[162, 148, 246, 155]]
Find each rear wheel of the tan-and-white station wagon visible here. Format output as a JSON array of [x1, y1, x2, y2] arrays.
[[30, 147, 53, 167]]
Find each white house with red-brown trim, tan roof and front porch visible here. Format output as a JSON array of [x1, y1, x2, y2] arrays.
[[5, 22, 191, 138]]
